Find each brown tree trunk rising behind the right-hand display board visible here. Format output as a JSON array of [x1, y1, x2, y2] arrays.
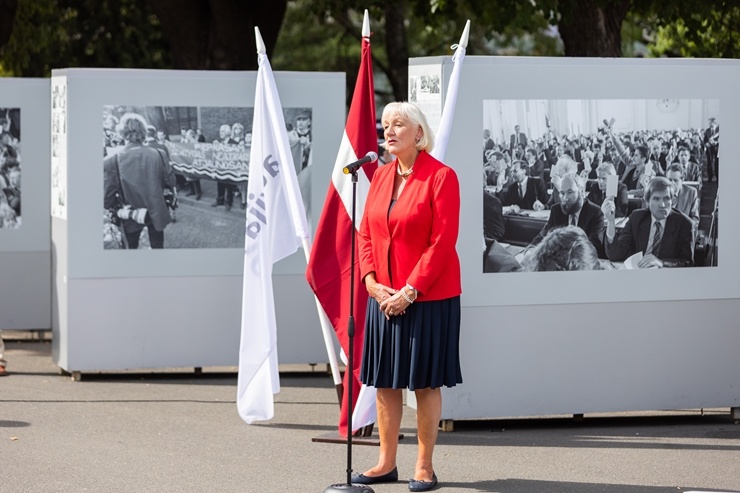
[[558, 0, 630, 57]]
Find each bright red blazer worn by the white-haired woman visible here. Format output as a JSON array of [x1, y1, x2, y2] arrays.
[[358, 151, 462, 301]]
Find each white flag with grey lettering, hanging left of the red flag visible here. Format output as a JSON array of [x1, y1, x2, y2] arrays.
[[236, 28, 308, 423]]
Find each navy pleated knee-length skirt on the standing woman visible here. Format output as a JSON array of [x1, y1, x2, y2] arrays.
[[360, 296, 462, 390]]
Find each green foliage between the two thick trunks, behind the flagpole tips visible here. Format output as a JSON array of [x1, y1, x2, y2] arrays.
[[271, 0, 563, 103]]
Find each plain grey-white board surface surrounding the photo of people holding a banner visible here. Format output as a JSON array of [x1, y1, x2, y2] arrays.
[[53, 69, 345, 371]]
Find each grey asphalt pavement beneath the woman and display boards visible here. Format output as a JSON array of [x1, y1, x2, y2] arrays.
[[0, 338, 740, 493]]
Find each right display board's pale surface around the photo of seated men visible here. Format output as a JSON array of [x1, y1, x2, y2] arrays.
[[409, 56, 740, 419]]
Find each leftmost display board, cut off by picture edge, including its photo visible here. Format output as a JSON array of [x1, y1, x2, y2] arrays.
[[0, 78, 51, 330]]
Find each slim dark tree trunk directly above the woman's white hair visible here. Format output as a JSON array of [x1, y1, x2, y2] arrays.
[[385, 2, 409, 101]]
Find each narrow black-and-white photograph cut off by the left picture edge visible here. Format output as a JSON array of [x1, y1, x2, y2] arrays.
[[0, 108, 23, 229]]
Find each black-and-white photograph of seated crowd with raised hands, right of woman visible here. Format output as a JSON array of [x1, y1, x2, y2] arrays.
[[481, 99, 720, 273]]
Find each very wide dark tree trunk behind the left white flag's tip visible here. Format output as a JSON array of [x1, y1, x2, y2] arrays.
[[149, 0, 287, 70]]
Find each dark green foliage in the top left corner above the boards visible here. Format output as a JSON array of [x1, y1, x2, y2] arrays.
[[0, 0, 172, 77]]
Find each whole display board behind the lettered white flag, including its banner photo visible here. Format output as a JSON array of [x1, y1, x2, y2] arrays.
[[52, 69, 345, 371]]
